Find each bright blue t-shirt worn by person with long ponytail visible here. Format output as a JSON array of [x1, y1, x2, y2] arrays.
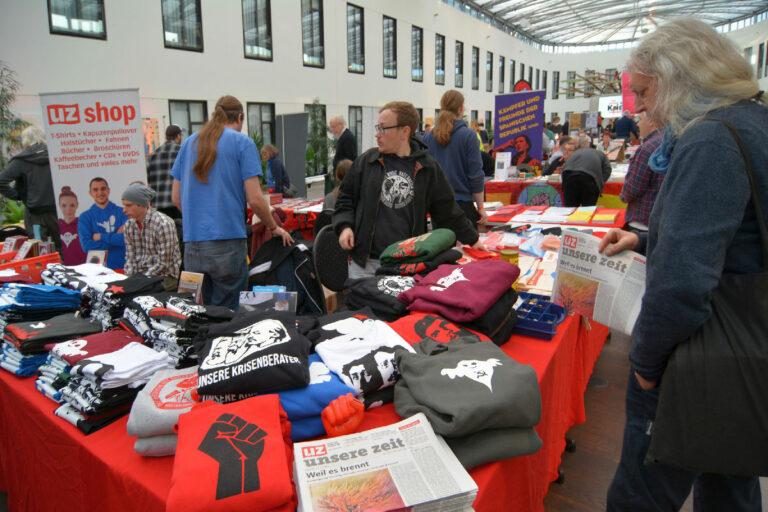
[[171, 128, 261, 242]]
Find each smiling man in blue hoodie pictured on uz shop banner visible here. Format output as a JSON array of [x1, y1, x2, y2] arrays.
[[77, 178, 128, 269]]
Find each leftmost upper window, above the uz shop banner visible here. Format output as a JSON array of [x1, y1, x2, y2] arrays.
[[48, 0, 107, 39]]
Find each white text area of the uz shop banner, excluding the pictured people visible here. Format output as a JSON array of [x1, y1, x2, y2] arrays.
[[40, 89, 147, 218]]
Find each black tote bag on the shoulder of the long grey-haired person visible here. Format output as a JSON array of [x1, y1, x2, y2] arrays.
[[646, 119, 768, 476]]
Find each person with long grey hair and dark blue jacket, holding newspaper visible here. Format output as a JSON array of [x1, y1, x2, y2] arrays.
[[601, 18, 768, 511]]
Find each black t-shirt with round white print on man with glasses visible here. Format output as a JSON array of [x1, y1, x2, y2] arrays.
[[370, 155, 415, 259]]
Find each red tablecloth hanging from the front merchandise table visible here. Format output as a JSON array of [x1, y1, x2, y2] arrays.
[[0, 317, 608, 512]]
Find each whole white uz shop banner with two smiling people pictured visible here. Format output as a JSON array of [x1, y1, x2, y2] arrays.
[[40, 89, 147, 269]]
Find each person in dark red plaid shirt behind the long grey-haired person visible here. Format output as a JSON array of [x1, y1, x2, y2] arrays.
[[620, 116, 664, 231]]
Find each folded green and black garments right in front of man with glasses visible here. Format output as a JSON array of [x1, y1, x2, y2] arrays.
[[379, 228, 461, 275]]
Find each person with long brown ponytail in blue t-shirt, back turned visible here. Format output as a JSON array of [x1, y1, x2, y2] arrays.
[[171, 96, 292, 309]]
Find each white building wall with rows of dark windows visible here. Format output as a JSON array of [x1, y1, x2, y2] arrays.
[[0, 0, 768, 147]]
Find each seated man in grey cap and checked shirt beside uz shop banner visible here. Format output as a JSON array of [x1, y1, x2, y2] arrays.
[[123, 183, 181, 291]]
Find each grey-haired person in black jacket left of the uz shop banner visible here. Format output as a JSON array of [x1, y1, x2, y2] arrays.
[[0, 125, 61, 251]]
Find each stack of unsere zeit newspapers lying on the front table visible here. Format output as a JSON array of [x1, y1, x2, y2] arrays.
[[293, 413, 477, 512]]
